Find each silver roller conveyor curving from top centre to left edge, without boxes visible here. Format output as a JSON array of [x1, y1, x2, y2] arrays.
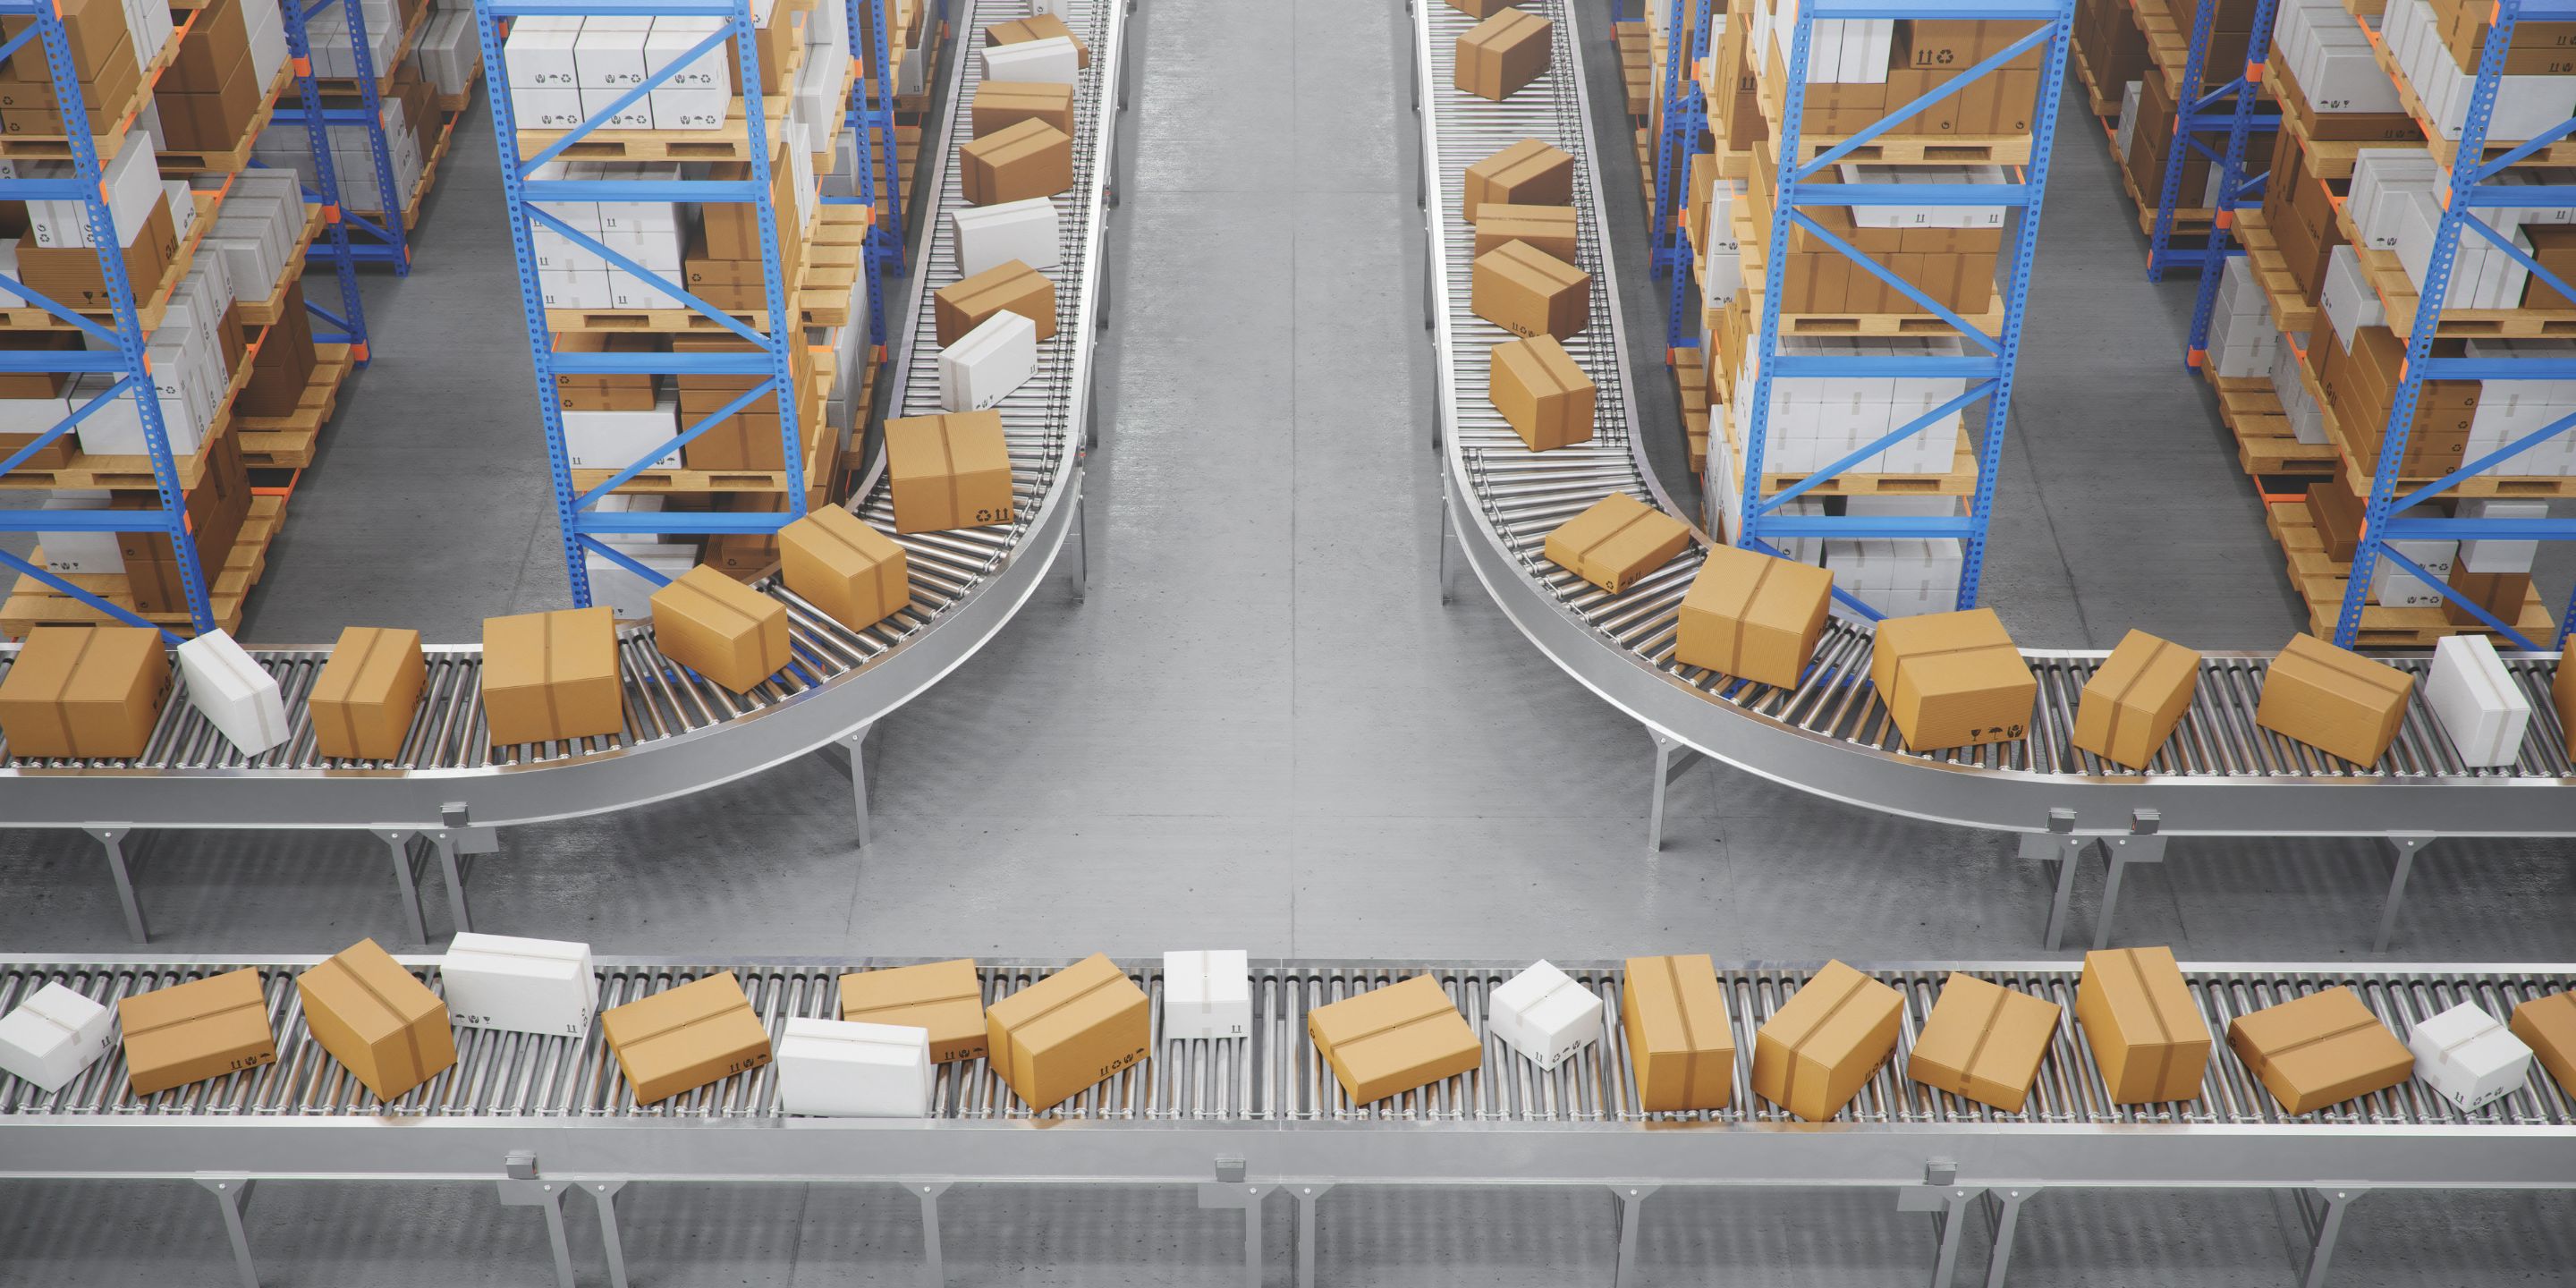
[[0, 0, 1126, 826]]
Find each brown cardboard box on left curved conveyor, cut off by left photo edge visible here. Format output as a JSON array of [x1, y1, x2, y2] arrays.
[[0, 626, 168, 760]]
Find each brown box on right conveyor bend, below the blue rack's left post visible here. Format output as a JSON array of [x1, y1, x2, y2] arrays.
[[1672, 547, 1835, 688]]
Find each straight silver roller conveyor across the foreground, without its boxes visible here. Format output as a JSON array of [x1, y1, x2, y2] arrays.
[[0, 955, 2576, 1188]]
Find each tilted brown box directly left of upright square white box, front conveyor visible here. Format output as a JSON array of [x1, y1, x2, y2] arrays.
[[984, 953, 1154, 1113]]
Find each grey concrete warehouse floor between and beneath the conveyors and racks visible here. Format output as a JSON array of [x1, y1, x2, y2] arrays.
[[0, 0, 2576, 1288]]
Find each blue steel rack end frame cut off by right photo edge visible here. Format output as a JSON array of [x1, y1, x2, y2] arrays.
[[2334, 0, 2576, 649]]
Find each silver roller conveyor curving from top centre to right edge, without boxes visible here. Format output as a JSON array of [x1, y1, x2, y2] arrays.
[[1414, 0, 2576, 837]]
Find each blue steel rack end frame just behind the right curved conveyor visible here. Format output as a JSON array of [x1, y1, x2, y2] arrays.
[[1736, 0, 2073, 621]]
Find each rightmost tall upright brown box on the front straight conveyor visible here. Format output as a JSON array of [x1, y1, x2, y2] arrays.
[[2076, 948, 2210, 1106]]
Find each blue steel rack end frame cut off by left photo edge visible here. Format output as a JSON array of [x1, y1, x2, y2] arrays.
[[0, 0, 214, 639]]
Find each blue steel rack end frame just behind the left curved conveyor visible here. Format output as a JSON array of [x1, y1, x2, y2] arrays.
[[474, 0, 806, 608]]
